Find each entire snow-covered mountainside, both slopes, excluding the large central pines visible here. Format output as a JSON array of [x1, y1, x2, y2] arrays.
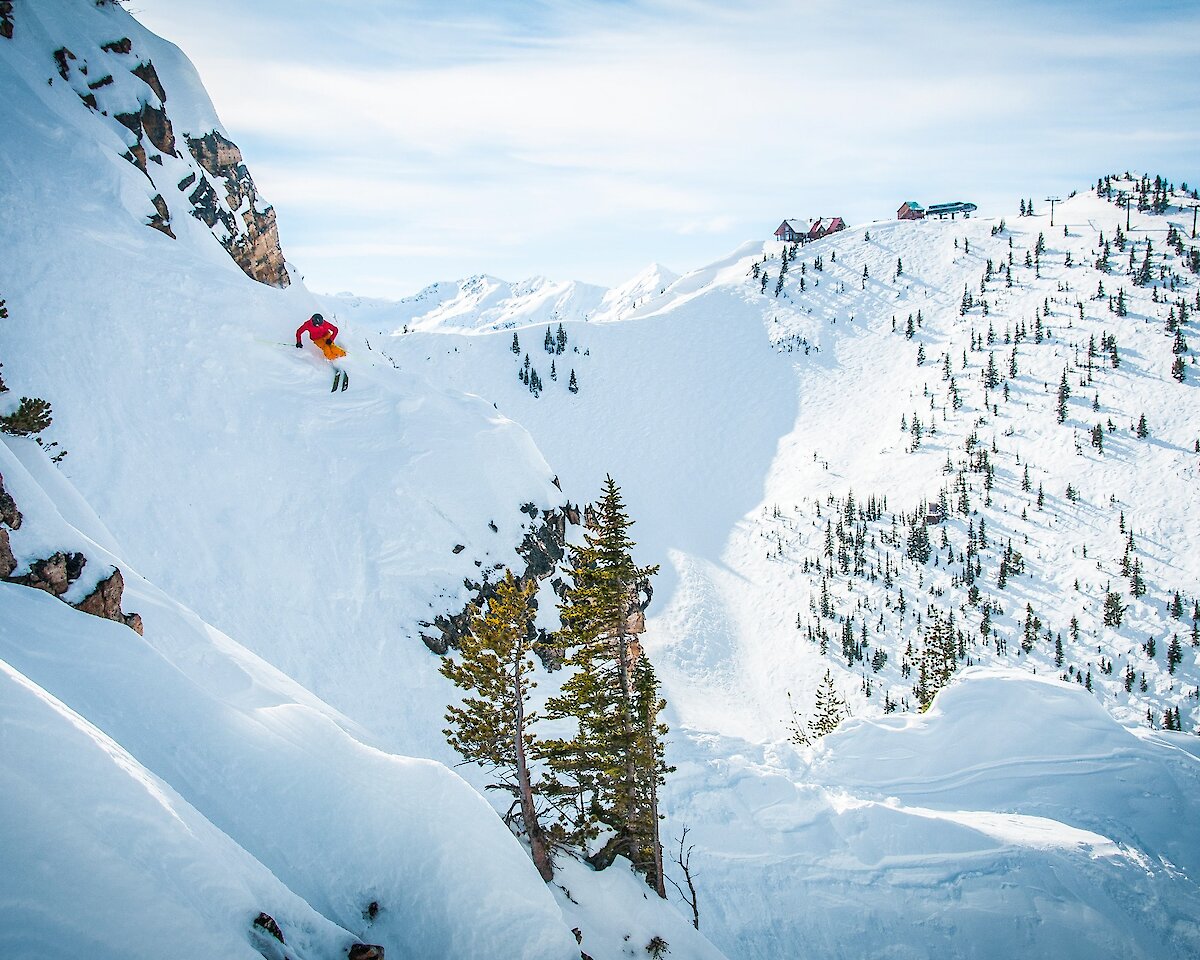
[[0, 0, 1200, 960]]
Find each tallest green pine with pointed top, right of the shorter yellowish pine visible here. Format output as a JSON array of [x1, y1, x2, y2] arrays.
[[540, 476, 666, 896]]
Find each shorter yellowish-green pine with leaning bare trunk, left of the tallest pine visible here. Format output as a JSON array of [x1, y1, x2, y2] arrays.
[[440, 570, 554, 882]]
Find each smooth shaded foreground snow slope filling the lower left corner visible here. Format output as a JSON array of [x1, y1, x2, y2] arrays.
[[0, 438, 574, 958]]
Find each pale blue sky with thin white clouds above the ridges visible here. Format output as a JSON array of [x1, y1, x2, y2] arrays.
[[127, 0, 1200, 298]]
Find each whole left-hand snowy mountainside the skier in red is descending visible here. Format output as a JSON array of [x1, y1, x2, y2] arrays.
[[0, 0, 720, 960]]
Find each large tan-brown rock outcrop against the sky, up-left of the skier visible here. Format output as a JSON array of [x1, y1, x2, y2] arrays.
[[187, 130, 292, 287]]
